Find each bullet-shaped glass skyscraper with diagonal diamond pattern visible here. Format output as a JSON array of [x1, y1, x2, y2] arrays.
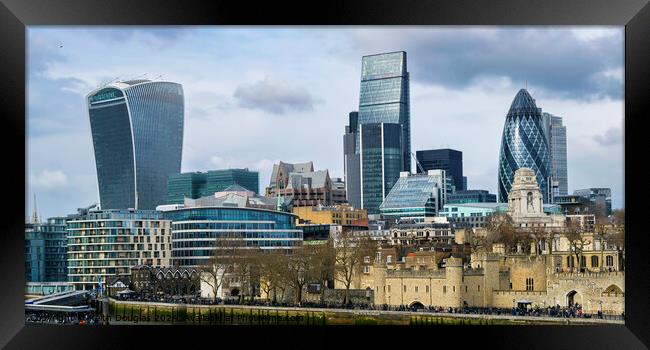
[[499, 89, 552, 203]]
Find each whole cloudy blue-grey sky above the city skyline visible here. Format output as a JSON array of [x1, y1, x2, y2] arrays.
[[25, 26, 624, 218]]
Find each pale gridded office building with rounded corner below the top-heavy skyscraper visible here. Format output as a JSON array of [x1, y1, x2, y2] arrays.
[[67, 209, 172, 290]]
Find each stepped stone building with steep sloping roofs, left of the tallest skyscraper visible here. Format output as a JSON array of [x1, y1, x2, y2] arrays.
[[265, 162, 345, 208]]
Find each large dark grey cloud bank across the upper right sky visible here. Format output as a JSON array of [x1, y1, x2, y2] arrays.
[[350, 27, 624, 100]]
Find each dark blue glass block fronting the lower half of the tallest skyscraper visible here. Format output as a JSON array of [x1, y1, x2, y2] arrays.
[[359, 123, 404, 214]]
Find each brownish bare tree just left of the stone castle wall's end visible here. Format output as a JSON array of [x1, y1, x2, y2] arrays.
[[334, 229, 377, 304]]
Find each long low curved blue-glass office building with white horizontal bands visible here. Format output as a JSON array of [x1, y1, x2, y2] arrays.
[[164, 207, 302, 267]]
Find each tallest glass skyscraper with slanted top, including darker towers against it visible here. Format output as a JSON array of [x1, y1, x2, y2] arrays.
[[343, 51, 411, 214]]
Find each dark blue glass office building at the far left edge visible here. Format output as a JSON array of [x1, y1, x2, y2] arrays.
[[25, 217, 68, 282]]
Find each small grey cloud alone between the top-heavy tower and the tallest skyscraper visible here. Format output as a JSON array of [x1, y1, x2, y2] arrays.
[[234, 77, 315, 114]]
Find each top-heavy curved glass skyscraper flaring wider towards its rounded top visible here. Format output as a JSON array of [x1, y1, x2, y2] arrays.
[[87, 80, 184, 210]]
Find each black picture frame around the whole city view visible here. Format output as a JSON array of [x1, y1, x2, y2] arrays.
[[0, 0, 650, 349]]
